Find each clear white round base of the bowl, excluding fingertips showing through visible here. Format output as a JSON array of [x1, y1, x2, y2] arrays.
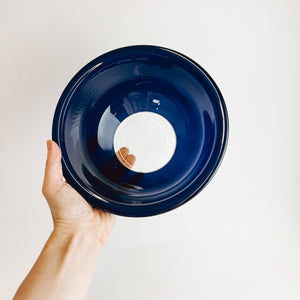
[[114, 111, 176, 173]]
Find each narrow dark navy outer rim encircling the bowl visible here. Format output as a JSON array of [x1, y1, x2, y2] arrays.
[[52, 45, 229, 217]]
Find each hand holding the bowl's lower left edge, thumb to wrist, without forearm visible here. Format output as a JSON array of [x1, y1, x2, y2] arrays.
[[42, 141, 116, 247]]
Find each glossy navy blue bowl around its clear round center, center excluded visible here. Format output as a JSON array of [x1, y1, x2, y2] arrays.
[[52, 46, 228, 217]]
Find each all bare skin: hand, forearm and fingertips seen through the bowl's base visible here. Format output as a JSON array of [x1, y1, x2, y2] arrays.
[[13, 141, 119, 300]]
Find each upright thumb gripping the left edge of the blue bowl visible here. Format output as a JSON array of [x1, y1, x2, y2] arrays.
[[42, 141, 64, 198]]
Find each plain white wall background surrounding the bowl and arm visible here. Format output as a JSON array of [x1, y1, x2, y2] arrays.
[[0, 0, 300, 300]]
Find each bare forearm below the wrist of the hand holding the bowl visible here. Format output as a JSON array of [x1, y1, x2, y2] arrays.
[[14, 230, 101, 300]]
